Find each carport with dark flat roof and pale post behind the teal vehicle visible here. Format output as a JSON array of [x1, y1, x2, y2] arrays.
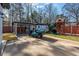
[[12, 22, 48, 34]]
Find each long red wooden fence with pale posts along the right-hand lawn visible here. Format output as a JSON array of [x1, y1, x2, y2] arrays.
[[56, 25, 79, 35]]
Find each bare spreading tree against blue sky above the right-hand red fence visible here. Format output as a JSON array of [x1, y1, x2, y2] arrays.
[[63, 3, 79, 23]]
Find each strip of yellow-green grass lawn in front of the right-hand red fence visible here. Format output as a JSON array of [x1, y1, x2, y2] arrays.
[[47, 34, 79, 42]]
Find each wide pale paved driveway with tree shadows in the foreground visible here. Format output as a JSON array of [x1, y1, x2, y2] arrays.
[[3, 36, 79, 56]]
